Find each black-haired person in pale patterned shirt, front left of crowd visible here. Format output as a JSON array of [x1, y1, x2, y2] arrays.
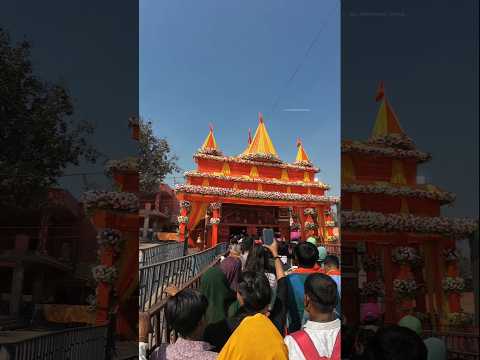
[[150, 289, 218, 360]]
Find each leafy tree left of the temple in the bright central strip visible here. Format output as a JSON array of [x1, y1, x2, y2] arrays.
[[139, 118, 180, 193]]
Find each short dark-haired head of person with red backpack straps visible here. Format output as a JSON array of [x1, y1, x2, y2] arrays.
[[305, 273, 338, 314]]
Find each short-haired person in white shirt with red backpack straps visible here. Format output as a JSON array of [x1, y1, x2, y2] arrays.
[[285, 273, 341, 360]]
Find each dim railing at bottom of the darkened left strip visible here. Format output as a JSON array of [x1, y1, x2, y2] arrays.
[[2, 326, 107, 360]]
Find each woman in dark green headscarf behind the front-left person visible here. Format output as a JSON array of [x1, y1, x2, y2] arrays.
[[200, 266, 236, 323]]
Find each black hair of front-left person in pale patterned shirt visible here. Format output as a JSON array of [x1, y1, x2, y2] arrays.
[[165, 289, 208, 337]]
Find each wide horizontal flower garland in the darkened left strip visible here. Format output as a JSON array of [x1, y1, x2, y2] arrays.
[[80, 190, 139, 213]]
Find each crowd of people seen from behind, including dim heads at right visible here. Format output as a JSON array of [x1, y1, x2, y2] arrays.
[[141, 236, 446, 360]]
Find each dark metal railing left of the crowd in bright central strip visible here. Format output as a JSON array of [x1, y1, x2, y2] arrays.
[[138, 243, 227, 311]]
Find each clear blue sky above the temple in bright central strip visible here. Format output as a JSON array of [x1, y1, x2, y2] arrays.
[[140, 0, 340, 195]]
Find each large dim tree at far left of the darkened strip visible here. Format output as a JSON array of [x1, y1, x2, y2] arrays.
[[0, 28, 99, 208]]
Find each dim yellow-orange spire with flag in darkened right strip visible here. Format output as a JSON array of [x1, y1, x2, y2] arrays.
[[371, 81, 405, 138]]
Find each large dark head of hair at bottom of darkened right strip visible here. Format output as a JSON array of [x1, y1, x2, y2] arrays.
[[365, 325, 427, 360]]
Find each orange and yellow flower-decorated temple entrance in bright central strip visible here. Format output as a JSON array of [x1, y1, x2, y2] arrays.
[[175, 114, 338, 248]]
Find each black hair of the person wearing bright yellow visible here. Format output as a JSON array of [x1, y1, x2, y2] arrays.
[[238, 271, 272, 312]]
